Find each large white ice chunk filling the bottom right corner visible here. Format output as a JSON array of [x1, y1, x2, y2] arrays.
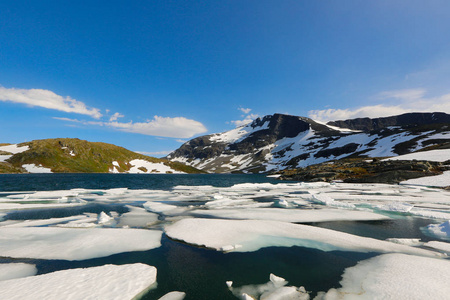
[[315, 253, 450, 300]]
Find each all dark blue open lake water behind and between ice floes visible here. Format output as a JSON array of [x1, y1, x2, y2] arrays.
[[0, 174, 442, 300]]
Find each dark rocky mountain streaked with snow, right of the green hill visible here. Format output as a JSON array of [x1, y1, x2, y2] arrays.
[[167, 113, 450, 173]]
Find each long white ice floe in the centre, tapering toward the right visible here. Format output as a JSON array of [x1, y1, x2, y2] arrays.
[[165, 219, 440, 256]]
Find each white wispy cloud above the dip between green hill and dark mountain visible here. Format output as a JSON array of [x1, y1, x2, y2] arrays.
[[55, 116, 207, 139]]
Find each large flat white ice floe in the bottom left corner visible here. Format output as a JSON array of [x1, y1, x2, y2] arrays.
[[0, 263, 156, 300]]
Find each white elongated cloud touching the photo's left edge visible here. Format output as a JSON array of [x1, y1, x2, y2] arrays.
[[0, 86, 102, 119]]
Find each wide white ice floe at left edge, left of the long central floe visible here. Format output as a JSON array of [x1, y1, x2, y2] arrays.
[[0, 227, 162, 260]]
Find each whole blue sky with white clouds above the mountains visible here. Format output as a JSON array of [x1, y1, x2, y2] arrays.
[[0, 0, 450, 157]]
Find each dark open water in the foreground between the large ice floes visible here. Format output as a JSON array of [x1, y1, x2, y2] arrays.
[[0, 236, 375, 300]]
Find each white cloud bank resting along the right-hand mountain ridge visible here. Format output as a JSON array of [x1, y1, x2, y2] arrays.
[[308, 89, 450, 121]]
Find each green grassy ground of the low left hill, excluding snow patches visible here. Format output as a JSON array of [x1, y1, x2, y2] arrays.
[[0, 138, 201, 173]]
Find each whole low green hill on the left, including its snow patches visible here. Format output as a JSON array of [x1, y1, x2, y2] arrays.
[[0, 138, 201, 173]]
